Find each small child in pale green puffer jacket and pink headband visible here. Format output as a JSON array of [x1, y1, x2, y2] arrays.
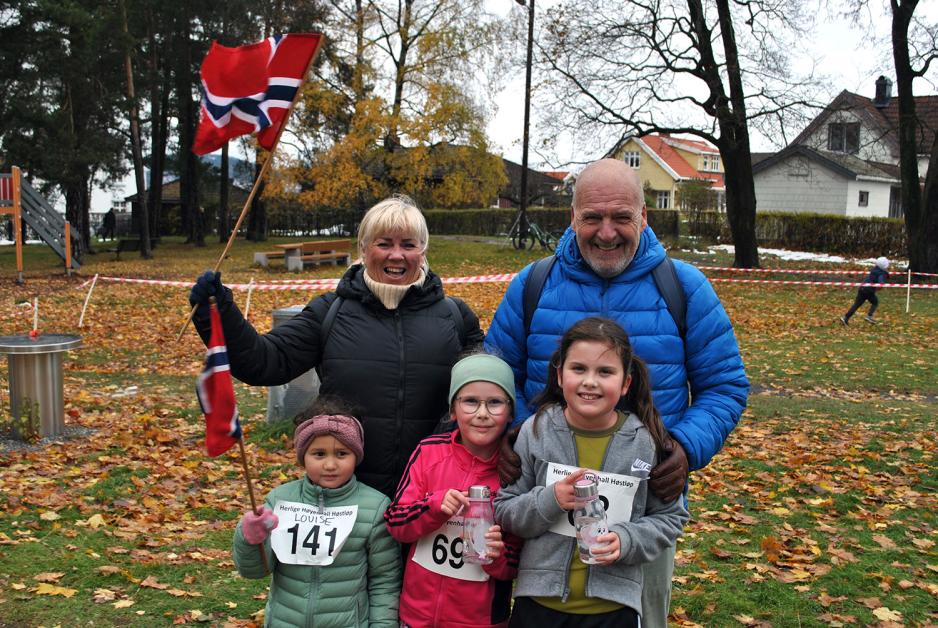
[[233, 398, 401, 628]]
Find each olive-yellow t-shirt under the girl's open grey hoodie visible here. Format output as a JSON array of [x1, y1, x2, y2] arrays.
[[534, 412, 625, 615]]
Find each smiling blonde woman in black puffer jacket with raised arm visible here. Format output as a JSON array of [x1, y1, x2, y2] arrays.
[[189, 196, 482, 496]]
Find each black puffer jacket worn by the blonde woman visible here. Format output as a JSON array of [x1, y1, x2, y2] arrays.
[[195, 264, 482, 496]]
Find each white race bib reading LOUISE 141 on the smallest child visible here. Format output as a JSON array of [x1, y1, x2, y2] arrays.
[[270, 501, 358, 566]]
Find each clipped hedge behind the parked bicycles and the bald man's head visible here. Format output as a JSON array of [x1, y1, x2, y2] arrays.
[[424, 207, 680, 236]]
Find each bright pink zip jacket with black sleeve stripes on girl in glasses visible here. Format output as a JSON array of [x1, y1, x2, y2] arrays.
[[384, 430, 521, 628]]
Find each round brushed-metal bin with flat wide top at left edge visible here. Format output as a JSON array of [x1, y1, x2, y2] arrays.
[[0, 334, 81, 437]]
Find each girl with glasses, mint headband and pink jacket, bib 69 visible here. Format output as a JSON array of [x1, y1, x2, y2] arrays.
[[385, 354, 524, 628]]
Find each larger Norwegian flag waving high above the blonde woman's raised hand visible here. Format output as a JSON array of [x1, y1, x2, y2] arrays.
[[192, 33, 322, 155]]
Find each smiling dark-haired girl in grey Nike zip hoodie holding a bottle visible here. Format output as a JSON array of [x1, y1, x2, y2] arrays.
[[495, 317, 687, 628]]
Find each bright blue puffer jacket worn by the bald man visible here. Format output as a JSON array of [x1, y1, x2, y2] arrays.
[[485, 227, 749, 471]]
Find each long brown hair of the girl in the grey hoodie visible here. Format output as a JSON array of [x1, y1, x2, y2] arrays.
[[532, 316, 667, 453]]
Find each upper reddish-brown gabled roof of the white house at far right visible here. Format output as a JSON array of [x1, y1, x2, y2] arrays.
[[792, 90, 938, 155]]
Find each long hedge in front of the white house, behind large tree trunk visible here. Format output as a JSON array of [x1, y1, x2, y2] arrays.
[[688, 212, 906, 256]]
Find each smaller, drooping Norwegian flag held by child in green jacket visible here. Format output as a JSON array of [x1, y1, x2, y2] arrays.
[[195, 303, 241, 457]]
